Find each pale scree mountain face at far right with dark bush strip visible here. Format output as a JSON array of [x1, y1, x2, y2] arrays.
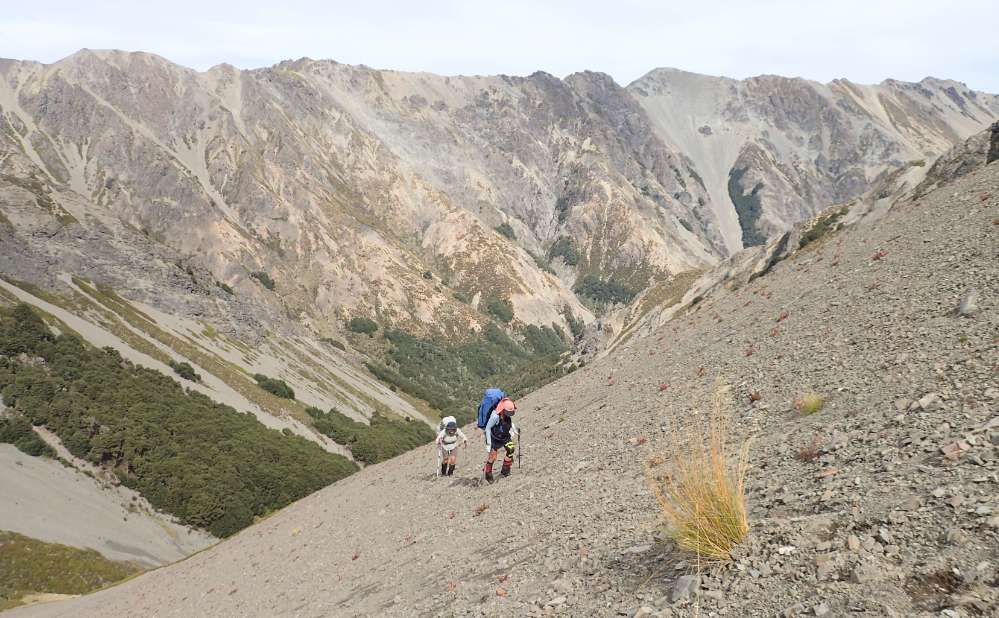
[[628, 69, 999, 250]]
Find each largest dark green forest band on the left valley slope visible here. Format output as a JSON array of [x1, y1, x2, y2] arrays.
[[0, 305, 357, 536]]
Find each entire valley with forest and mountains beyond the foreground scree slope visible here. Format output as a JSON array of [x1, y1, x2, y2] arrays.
[[0, 50, 999, 612]]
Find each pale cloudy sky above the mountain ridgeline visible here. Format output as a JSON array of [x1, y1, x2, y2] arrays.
[[0, 0, 999, 93]]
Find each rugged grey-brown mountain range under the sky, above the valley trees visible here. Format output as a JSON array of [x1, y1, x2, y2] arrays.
[[0, 50, 999, 336]]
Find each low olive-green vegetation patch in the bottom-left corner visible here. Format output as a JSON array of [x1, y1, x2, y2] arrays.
[[0, 530, 141, 610]]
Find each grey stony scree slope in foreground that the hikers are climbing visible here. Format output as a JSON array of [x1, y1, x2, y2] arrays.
[[11, 142, 999, 617]]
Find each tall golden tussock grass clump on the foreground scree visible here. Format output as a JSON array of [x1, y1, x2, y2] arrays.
[[645, 386, 749, 561]]
